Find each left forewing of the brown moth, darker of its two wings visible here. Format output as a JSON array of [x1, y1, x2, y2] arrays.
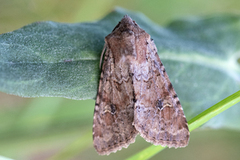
[[93, 39, 138, 155]]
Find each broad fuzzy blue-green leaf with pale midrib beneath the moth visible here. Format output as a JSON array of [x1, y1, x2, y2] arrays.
[[0, 9, 240, 129]]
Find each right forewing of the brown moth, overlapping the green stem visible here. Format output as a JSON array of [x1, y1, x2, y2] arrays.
[[133, 37, 189, 148]]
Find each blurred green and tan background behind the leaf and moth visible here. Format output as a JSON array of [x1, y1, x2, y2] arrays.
[[0, 0, 240, 160]]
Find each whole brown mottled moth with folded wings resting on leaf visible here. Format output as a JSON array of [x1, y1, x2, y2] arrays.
[[93, 16, 189, 155]]
